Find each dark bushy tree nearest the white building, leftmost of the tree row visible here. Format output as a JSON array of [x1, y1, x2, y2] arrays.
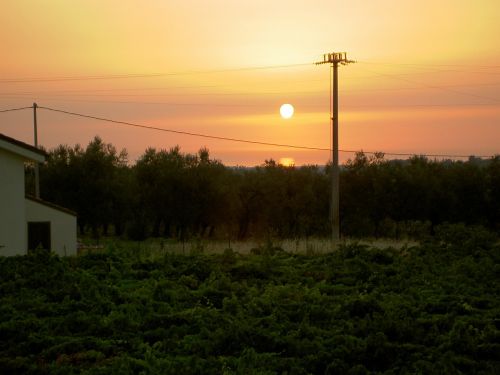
[[40, 136, 127, 236]]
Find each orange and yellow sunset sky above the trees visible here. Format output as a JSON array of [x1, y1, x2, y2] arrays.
[[0, 0, 500, 165]]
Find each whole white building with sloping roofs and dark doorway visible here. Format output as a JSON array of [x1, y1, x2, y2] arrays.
[[0, 134, 76, 256]]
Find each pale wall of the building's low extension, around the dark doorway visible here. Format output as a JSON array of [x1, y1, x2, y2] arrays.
[[23, 199, 76, 256]]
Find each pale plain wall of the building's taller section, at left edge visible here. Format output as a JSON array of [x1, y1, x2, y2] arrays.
[[0, 149, 27, 256]]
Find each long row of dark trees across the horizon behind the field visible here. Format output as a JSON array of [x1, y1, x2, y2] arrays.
[[31, 137, 500, 240]]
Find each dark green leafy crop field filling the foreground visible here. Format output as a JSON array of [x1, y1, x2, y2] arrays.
[[0, 227, 500, 374]]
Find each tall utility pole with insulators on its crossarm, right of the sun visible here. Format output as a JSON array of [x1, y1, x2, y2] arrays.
[[316, 52, 355, 246]]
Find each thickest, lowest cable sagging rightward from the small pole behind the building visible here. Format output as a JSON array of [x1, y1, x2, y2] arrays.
[[36, 105, 493, 159]]
